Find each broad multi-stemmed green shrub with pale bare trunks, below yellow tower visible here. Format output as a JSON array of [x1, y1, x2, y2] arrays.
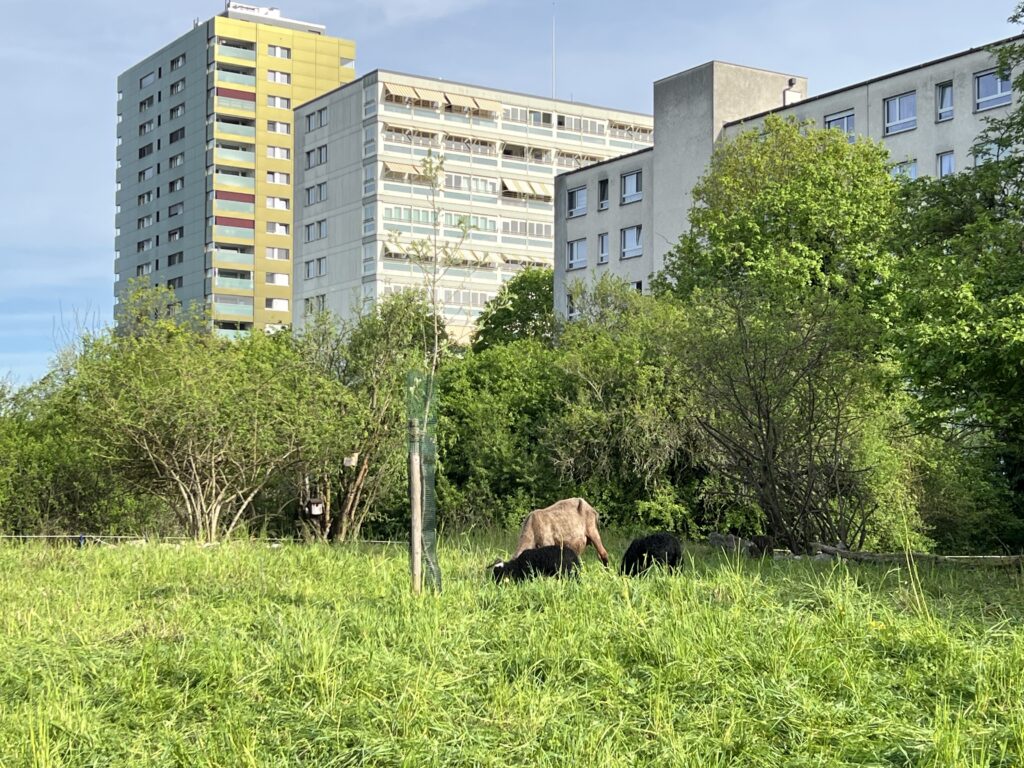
[[76, 288, 348, 541]]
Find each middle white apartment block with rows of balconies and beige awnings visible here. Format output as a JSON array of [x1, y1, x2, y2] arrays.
[[294, 71, 653, 341]]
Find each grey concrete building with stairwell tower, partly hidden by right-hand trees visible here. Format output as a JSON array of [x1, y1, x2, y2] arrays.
[[555, 36, 1024, 316]]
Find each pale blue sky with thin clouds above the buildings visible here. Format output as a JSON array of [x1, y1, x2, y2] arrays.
[[0, 0, 1018, 384]]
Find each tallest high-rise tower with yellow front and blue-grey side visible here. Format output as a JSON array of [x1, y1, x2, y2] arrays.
[[114, 2, 355, 335]]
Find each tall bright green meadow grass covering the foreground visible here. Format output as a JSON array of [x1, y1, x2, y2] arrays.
[[0, 540, 1024, 768]]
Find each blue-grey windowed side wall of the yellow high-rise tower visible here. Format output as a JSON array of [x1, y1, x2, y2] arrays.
[[114, 23, 212, 313]]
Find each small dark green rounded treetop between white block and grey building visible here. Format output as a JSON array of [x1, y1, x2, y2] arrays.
[[473, 267, 556, 352]]
